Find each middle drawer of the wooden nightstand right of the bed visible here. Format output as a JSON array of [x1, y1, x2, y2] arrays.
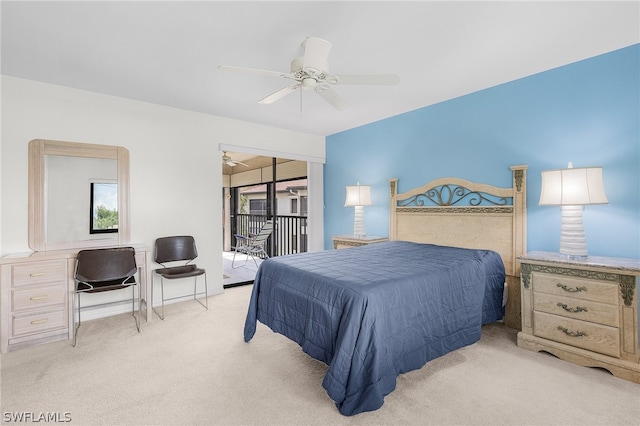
[[533, 288, 620, 327]]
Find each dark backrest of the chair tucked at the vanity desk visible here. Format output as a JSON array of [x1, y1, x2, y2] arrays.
[[75, 247, 138, 283]]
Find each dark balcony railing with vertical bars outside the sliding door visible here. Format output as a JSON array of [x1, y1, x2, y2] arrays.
[[231, 214, 307, 257]]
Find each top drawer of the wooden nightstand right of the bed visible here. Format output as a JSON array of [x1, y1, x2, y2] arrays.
[[531, 272, 618, 305]]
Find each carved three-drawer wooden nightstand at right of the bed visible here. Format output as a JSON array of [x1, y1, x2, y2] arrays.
[[518, 252, 640, 383]]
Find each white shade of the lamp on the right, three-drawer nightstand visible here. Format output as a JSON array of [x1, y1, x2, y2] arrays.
[[538, 167, 609, 206]]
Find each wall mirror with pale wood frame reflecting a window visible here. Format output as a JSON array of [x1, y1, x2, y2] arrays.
[[29, 139, 130, 251]]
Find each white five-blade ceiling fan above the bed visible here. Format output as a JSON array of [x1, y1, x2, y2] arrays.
[[218, 37, 400, 110]]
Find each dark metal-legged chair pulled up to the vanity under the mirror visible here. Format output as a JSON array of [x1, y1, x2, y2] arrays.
[[73, 247, 140, 347]]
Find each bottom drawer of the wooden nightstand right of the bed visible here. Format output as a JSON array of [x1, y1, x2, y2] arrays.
[[533, 311, 620, 358]]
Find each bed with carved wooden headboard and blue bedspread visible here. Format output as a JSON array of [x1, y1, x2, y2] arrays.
[[244, 166, 526, 415]]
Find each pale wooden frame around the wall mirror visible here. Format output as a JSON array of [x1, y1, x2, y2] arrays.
[[29, 139, 131, 251]]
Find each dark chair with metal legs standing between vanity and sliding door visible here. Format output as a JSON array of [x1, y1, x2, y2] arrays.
[[153, 236, 209, 320]]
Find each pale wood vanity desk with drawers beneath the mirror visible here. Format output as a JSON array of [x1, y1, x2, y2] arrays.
[[0, 244, 152, 353]]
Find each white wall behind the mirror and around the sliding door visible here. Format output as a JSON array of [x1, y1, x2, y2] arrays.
[[0, 76, 325, 308]]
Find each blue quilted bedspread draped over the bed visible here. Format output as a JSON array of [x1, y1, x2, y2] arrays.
[[244, 241, 505, 415]]
